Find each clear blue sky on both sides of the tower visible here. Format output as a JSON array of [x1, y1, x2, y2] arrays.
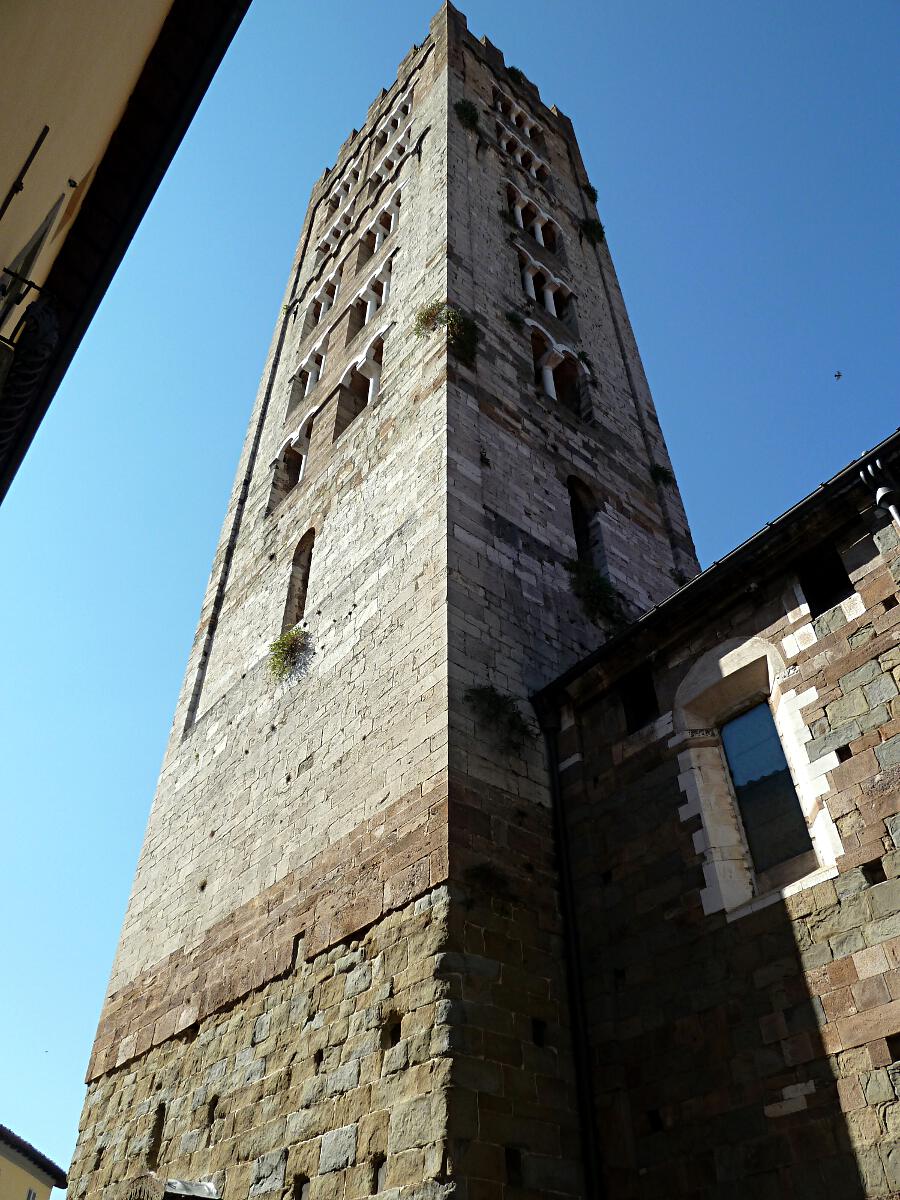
[[0, 0, 900, 1166]]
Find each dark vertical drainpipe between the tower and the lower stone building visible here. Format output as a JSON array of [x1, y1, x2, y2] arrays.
[[535, 702, 607, 1200]]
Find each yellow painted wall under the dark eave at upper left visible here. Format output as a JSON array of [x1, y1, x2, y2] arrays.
[[0, 0, 172, 333]]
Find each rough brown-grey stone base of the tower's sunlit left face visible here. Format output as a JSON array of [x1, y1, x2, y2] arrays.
[[70, 888, 457, 1200]]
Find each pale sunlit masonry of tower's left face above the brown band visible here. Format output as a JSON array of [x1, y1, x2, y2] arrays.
[[110, 18, 448, 996]]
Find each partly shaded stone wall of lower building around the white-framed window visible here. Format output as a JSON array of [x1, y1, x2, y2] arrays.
[[559, 510, 900, 1200]]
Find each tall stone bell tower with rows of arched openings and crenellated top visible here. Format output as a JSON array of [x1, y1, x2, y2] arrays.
[[70, 5, 697, 1200]]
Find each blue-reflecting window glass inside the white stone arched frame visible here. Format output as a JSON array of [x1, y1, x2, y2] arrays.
[[721, 703, 812, 872]]
